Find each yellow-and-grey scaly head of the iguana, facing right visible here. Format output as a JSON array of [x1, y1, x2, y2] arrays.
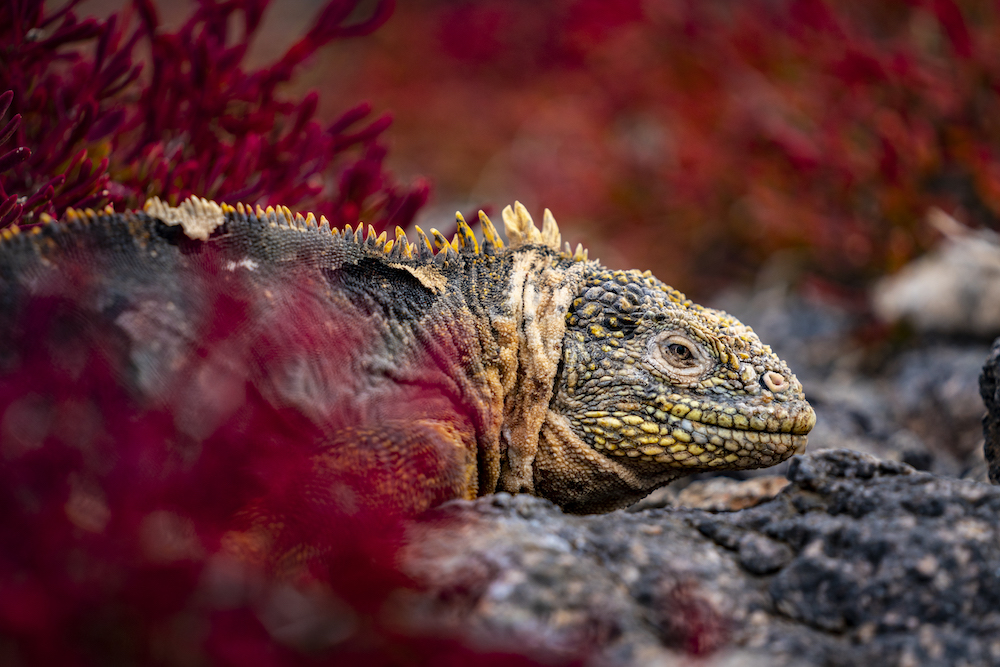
[[496, 201, 816, 512]]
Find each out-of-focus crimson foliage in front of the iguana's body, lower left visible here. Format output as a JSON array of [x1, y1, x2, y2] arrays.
[[0, 253, 564, 667]]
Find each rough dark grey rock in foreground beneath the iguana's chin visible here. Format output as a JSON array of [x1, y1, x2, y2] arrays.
[[401, 450, 1000, 666]]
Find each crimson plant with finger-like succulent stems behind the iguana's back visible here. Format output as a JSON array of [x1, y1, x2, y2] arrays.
[[0, 0, 429, 228]]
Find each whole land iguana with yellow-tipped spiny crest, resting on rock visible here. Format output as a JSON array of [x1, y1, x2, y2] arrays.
[[0, 198, 815, 513]]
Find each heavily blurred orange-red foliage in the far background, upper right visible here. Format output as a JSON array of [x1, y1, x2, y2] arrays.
[[330, 0, 1000, 294]]
